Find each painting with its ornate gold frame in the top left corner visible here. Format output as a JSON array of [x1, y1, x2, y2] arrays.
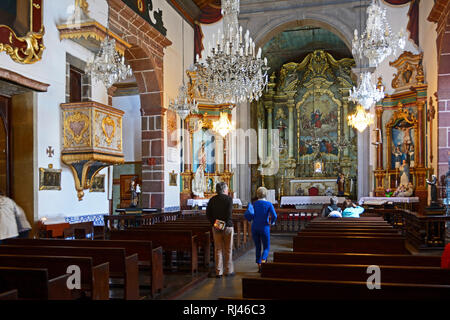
[[0, 0, 45, 64]]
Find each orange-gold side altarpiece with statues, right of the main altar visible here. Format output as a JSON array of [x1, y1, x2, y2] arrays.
[[374, 51, 433, 208]]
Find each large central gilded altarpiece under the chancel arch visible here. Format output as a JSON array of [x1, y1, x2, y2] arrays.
[[252, 50, 357, 197]]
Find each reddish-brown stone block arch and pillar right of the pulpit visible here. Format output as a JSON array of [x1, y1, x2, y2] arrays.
[[108, 0, 172, 208]]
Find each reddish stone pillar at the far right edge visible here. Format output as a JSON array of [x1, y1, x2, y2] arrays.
[[428, 0, 450, 182]]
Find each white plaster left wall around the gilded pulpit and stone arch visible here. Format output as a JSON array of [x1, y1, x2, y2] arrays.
[[0, 0, 194, 219]]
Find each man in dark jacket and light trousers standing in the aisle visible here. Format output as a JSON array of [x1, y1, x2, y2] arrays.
[[206, 182, 234, 278]]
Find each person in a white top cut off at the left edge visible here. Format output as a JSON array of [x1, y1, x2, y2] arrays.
[[0, 194, 31, 244]]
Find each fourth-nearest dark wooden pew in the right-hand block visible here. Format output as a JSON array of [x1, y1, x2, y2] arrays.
[[293, 235, 408, 254]]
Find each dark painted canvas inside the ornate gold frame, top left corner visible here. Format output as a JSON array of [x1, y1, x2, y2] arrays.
[[0, 0, 31, 37]]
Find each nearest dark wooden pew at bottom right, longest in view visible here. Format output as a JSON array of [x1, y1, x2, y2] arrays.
[[242, 278, 450, 301]]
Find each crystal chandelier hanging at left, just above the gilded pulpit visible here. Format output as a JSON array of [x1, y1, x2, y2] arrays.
[[85, 36, 132, 88]]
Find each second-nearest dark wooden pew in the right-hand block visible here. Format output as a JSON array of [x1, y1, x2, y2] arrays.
[[261, 262, 450, 285]]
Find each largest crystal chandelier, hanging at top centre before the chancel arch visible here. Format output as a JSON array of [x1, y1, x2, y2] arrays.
[[195, 0, 269, 104]]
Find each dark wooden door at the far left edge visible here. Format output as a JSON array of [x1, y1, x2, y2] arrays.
[[0, 96, 11, 197]]
